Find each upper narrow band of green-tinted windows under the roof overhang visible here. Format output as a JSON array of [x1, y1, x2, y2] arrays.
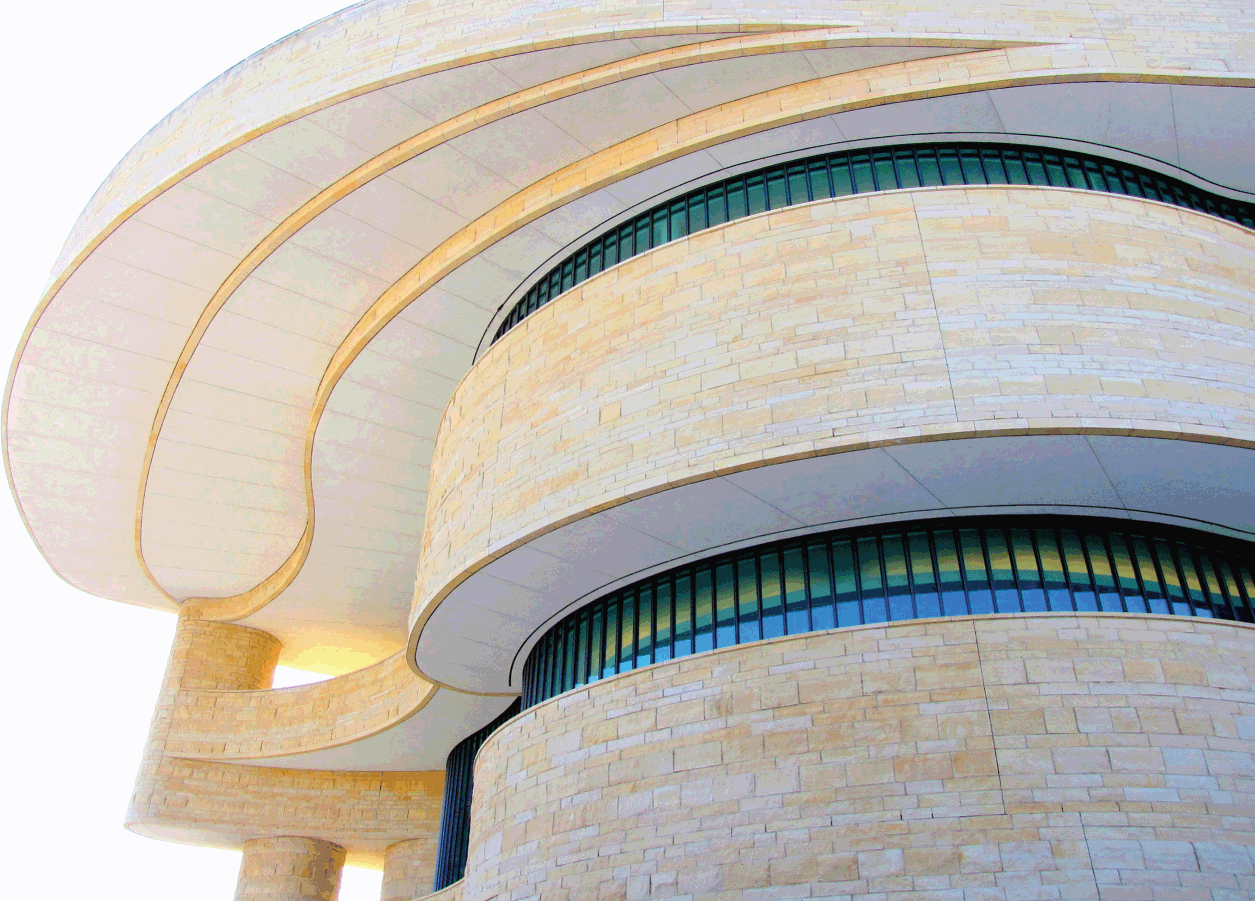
[[492, 144, 1255, 343]]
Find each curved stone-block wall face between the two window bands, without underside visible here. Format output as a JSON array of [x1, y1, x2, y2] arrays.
[[414, 187, 1255, 634]]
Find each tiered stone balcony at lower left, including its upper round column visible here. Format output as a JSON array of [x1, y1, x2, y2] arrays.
[[127, 616, 498, 883]]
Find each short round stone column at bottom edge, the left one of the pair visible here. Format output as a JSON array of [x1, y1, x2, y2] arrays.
[[235, 836, 344, 901]]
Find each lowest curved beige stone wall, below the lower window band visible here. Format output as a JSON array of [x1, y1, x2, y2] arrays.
[[462, 615, 1255, 901]]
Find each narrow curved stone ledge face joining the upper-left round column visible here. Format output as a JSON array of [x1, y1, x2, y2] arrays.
[[166, 654, 438, 760]]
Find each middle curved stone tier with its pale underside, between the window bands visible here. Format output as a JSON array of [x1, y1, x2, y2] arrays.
[[412, 187, 1255, 691]]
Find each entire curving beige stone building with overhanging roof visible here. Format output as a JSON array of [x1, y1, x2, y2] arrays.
[[4, 0, 1255, 901]]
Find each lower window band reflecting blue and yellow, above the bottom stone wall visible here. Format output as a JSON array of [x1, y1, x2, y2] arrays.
[[522, 517, 1255, 709]]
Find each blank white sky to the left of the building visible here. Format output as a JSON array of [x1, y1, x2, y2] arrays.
[[0, 0, 396, 901]]
